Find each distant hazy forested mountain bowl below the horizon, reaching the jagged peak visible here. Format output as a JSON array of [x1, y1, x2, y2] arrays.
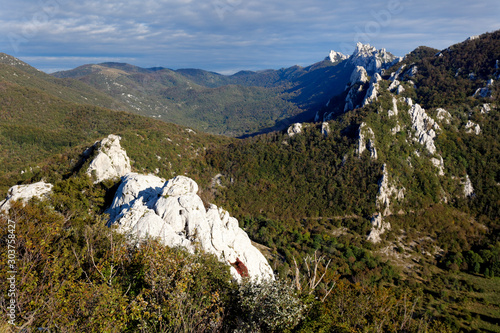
[[53, 44, 396, 136]]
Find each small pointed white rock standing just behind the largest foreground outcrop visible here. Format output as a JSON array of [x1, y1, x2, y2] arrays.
[[87, 134, 131, 183]]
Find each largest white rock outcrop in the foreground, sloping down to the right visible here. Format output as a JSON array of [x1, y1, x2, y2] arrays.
[[107, 173, 274, 280]]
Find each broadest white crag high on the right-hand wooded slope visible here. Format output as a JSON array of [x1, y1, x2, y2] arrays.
[[408, 104, 440, 154]]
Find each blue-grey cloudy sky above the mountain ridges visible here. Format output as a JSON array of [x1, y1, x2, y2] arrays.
[[0, 0, 500, 74]]
